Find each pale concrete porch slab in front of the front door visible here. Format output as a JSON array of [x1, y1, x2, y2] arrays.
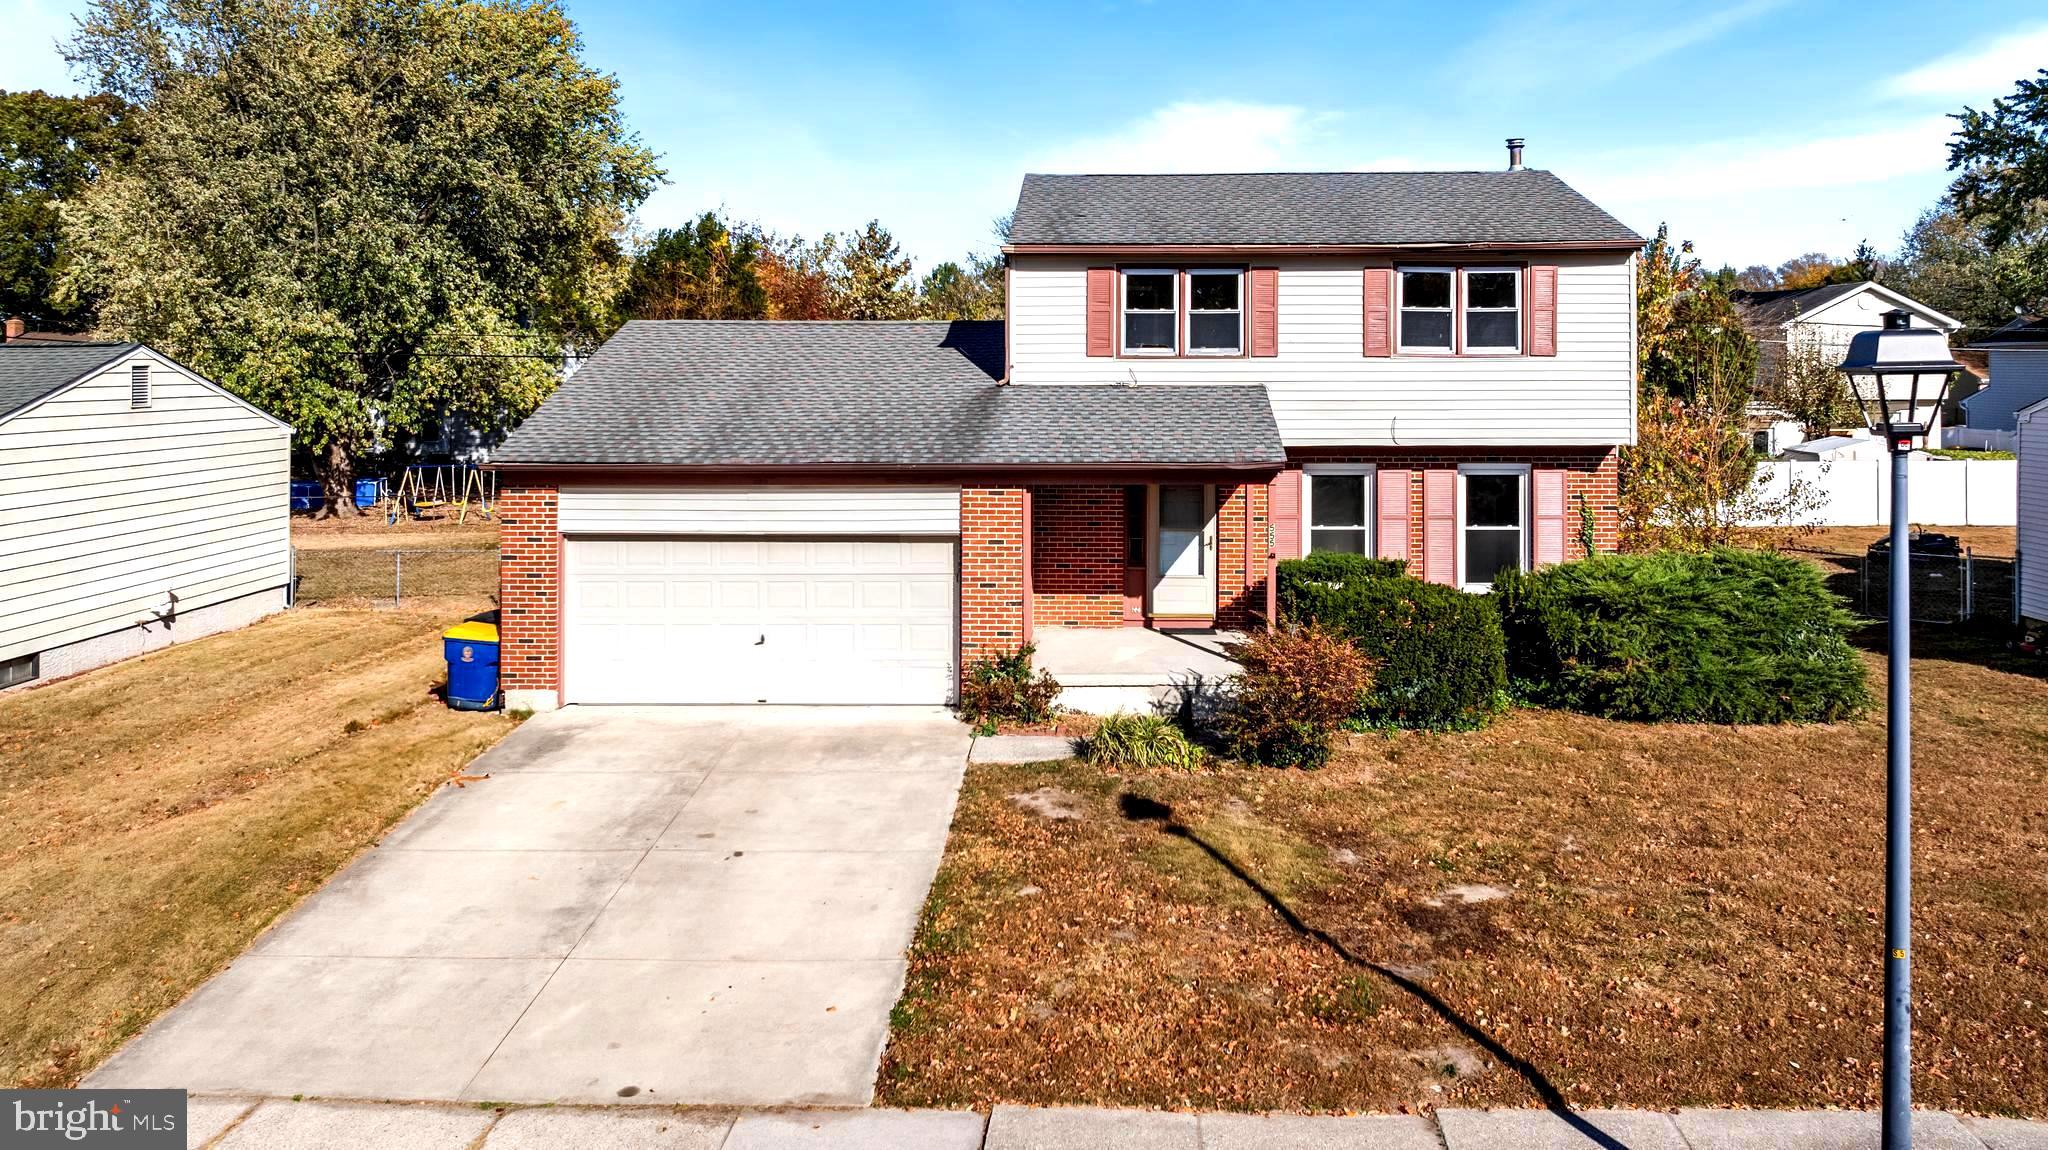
[[1032, 626, 1243, 714]]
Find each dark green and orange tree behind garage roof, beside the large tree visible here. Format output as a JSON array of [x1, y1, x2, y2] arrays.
[[621, 211, 768, 319]]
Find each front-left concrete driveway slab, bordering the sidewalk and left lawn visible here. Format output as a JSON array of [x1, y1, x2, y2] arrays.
[[82, 956, 557, 1099]]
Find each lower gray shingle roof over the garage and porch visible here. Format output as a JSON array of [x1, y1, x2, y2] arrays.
[[494, 319, 1286, 467]]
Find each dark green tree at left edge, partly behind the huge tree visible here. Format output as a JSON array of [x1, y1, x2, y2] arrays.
[[0, 92, 133, 331]]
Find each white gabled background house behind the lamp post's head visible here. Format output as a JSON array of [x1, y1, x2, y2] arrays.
[[1729, 280, 1962, 446]]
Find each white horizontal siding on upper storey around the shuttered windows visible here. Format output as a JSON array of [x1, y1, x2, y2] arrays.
[[1010, 252, 1636, 446]]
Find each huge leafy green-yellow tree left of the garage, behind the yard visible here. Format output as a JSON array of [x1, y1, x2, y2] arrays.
[[66, 0, 659, 507]]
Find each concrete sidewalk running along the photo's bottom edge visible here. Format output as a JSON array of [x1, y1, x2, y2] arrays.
[[186, 1097, 2048, 1150]]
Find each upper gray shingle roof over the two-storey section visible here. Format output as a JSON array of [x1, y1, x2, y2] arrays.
[[1010, 170, 1642, 246]]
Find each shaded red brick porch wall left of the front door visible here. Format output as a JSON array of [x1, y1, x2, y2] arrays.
[[1030, 483, 1126, 626]]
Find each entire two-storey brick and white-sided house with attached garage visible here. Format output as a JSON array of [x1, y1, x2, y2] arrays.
[[494, 148, 1642, 708]]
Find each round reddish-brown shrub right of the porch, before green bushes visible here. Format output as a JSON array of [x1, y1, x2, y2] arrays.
[[1217, 626, 1372, 767]]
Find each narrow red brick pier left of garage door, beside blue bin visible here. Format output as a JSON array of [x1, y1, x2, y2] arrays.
[[498, 477, 561, 692]]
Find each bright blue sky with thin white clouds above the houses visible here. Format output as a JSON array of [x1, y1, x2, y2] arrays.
[[0, 0, 2048, 266]]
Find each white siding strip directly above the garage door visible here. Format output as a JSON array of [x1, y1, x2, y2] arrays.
[[557, 485, 961, 536]]
